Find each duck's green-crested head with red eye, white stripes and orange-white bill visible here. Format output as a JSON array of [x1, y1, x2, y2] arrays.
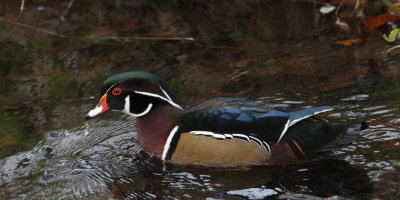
[[86, 71, 183, 119]]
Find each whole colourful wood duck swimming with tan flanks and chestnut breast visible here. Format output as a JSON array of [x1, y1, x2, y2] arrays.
[[87, 71, 366, 166]]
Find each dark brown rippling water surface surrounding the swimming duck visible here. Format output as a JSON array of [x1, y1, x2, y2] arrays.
[[0, 0, 400, 199]]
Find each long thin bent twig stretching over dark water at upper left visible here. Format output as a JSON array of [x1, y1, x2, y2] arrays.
[[0, 17, 194, 41]]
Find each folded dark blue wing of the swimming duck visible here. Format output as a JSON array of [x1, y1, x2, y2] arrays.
[[181, 103, 332, 143]]
